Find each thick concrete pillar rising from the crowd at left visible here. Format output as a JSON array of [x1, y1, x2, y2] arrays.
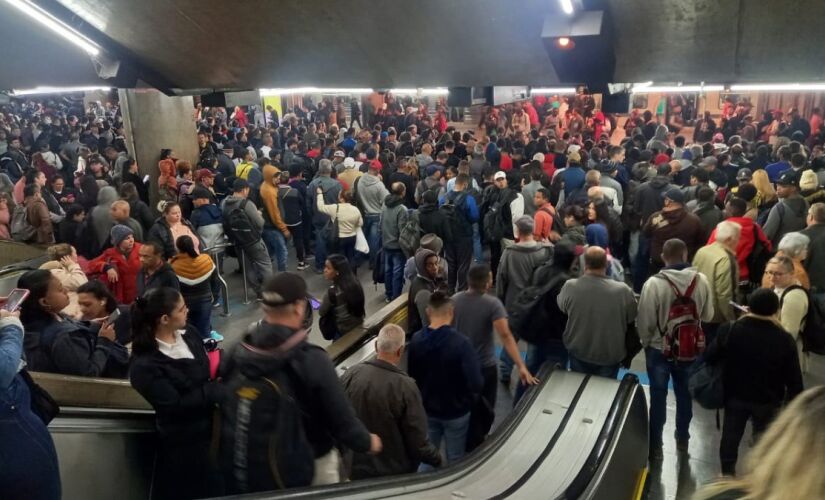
[[118, 89, 198, 209]]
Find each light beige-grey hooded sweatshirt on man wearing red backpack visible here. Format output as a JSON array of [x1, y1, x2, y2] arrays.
[[636, 264, 713, 350]]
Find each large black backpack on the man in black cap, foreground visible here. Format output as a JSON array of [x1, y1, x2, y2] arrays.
[[218, 322, 315, 494]]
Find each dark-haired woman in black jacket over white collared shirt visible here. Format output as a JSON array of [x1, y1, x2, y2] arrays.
[[129, 287, 221, 499]]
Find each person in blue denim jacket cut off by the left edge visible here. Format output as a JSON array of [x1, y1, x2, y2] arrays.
[[0, 304, 61, 500]]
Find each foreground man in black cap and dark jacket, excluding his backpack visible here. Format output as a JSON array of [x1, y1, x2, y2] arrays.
[[221, 272, 382, 486]]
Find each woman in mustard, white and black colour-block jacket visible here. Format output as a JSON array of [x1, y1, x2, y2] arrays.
[[170, 235, 216, 340]]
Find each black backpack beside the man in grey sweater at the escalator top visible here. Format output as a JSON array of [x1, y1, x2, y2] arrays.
[[507, 263, 569, 344]]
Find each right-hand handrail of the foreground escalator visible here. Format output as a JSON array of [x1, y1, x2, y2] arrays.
[[558, 373, 639, 499]]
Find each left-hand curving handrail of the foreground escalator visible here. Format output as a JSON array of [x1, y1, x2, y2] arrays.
[[240, 363, 556, 500]]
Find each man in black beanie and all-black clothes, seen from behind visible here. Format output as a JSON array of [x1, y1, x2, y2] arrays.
[[705, 288, 802, 476]]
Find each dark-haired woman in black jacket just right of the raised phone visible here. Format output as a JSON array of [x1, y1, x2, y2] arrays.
[[17, 269, 129, 378]]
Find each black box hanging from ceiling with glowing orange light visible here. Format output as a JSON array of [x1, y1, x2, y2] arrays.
[[541, 10, 616, 93]]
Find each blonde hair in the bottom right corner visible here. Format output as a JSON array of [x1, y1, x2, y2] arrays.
[[694, 386, 825, 500]]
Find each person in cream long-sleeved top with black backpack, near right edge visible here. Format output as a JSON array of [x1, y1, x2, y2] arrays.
[[765, 255, 808, 373]]
